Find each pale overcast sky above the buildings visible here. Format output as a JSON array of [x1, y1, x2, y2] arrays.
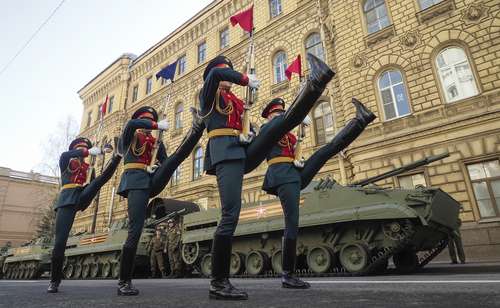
[[0, 0, 212, 171]]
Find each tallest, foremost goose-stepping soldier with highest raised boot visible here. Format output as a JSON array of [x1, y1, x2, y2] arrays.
[[200, 54, 334, 300]]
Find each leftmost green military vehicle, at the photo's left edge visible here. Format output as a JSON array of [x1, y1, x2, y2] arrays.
[[2, 237, 52, 279]]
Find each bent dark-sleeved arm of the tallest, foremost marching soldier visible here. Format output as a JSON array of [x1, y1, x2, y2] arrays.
[[200, 67, 248, 112]]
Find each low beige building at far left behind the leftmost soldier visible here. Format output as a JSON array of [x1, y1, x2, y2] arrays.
[[0, 167, 59, 247]]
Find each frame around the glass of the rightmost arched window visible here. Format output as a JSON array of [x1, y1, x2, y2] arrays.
[[431, 40, 483, 105]]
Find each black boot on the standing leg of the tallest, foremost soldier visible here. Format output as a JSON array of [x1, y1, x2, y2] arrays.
[[209, 235, 248, 300]]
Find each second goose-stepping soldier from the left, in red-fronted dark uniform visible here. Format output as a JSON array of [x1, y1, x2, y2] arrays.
[[117, 107, 205, 295]]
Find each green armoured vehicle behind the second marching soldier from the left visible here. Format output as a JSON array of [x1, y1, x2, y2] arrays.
[[63, 199, 197, 279]]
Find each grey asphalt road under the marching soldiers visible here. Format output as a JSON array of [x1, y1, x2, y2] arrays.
[[0, 264, 500, 308]]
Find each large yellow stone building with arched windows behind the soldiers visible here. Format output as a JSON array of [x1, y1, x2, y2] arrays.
[[75, 0, 500, 259]]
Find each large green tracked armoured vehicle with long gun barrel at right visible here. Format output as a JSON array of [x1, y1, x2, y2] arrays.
[[181, 154, 460, 277]]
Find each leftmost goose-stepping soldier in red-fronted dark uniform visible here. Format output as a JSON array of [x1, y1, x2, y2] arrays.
[[47, 138, 122, 293]]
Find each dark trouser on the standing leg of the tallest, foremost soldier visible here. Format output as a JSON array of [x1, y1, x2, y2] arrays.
[[215, 159, 245, 236]]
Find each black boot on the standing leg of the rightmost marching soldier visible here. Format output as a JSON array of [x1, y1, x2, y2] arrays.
[[281, 238, 311, 289]]
